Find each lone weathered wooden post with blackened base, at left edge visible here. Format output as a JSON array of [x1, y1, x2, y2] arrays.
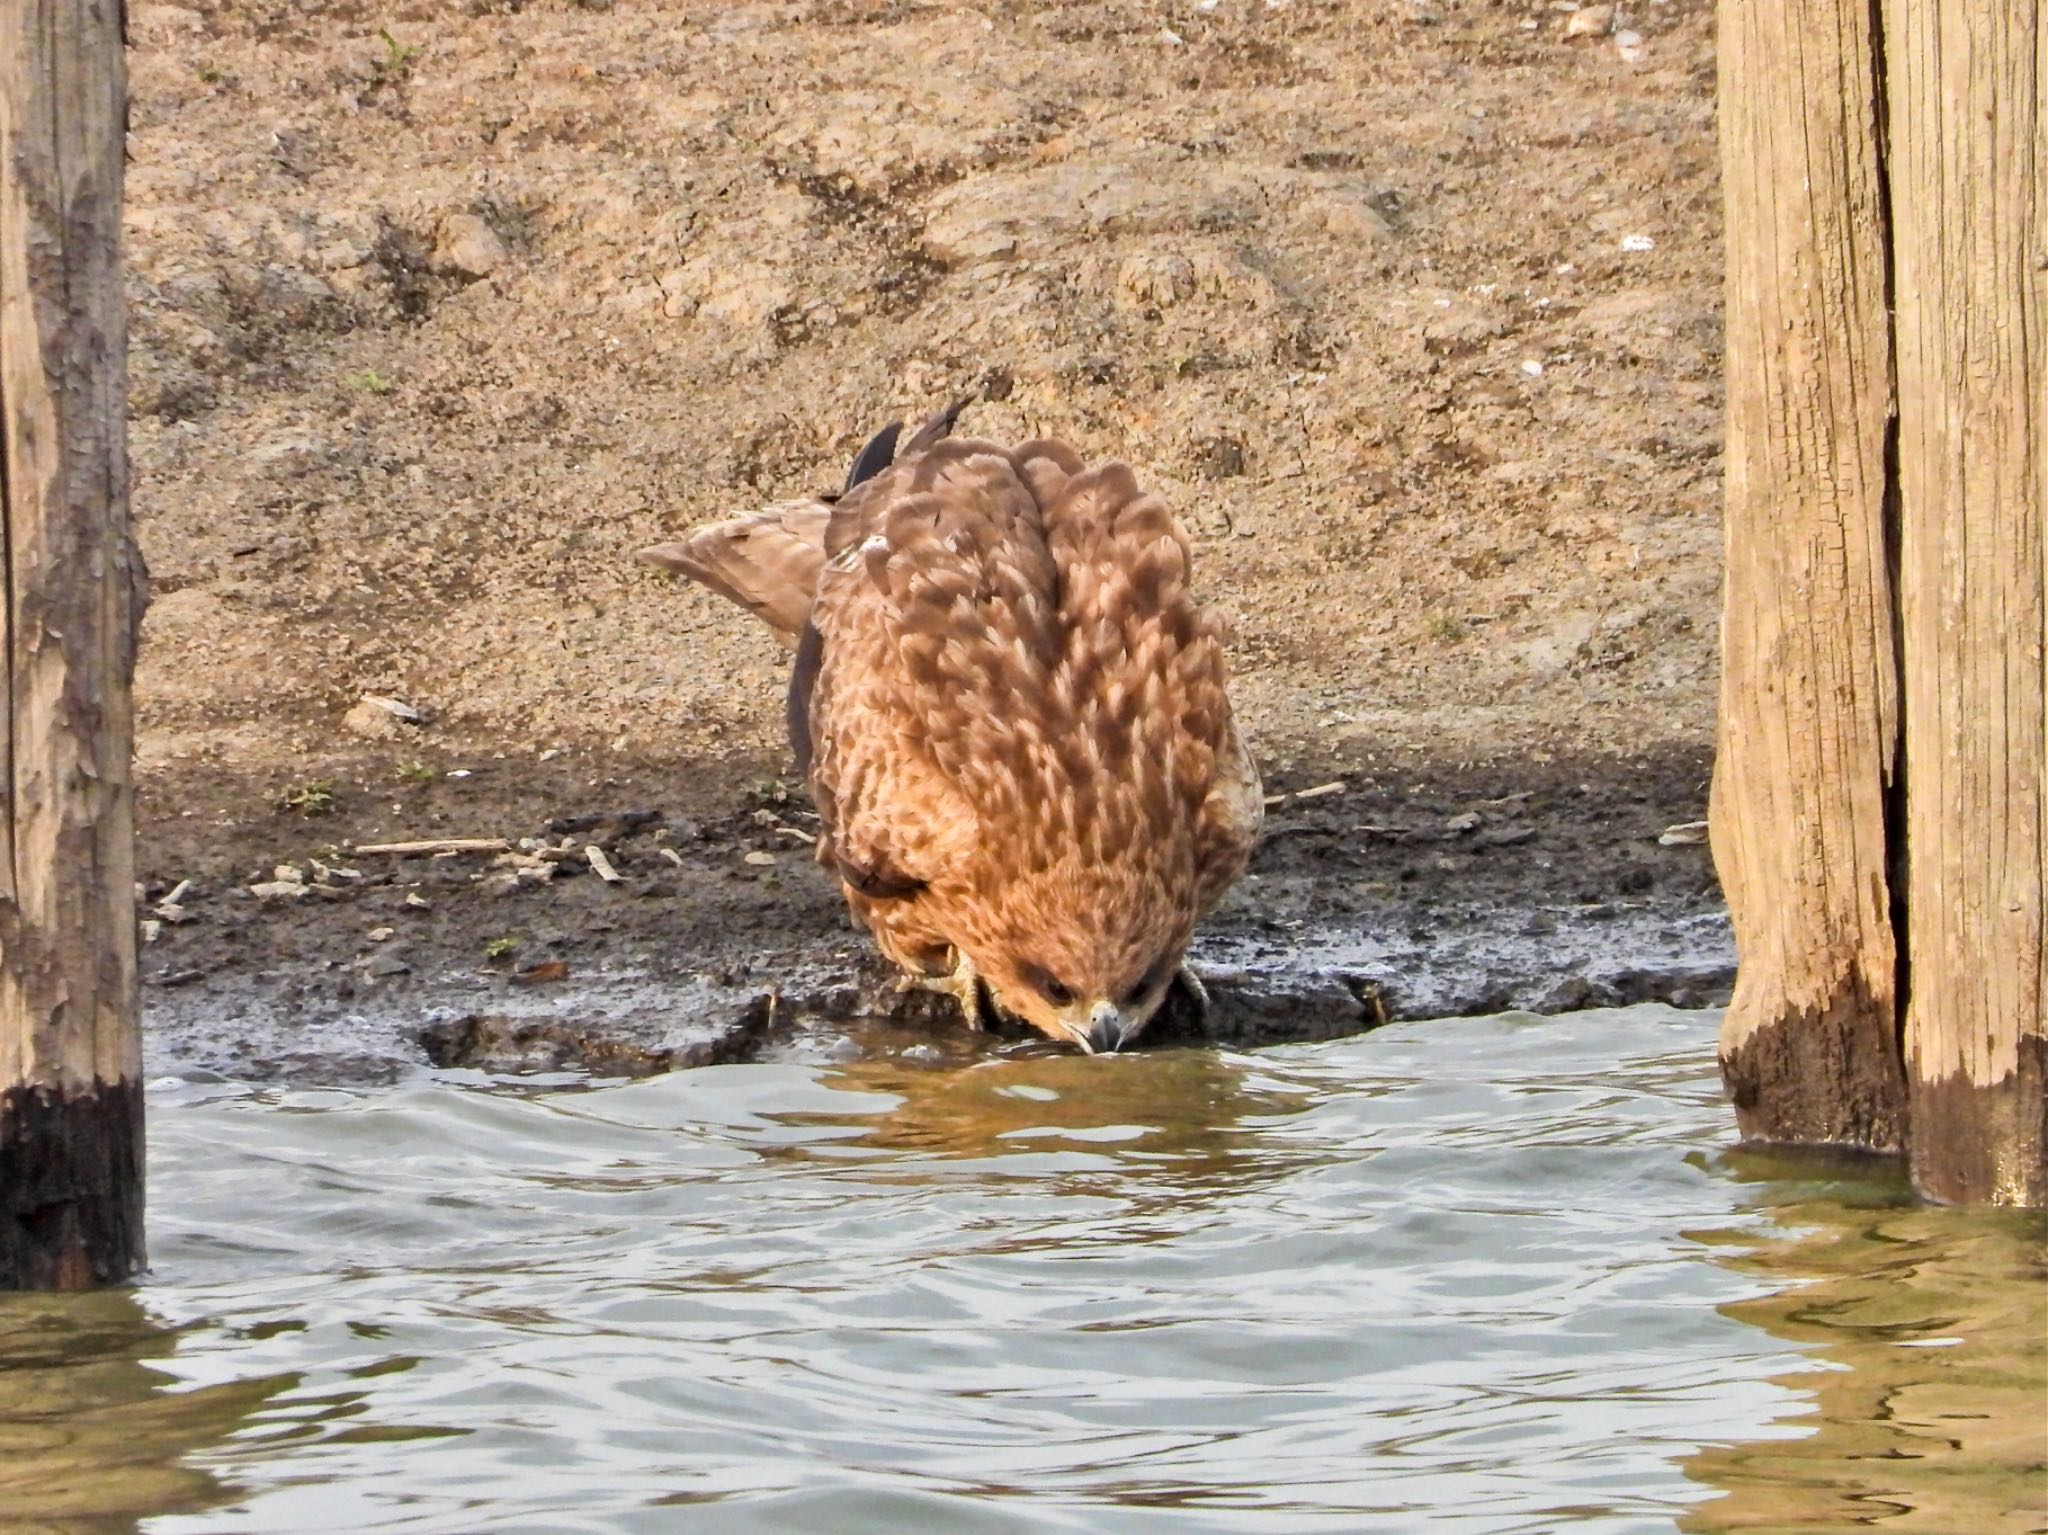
[[0, 0, 143, 1289]]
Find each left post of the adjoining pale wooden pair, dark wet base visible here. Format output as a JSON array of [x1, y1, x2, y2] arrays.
[[1712, 0, 1905, 1148]]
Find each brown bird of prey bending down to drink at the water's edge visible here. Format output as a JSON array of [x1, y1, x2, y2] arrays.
[[645, 401, 1264, 1052]]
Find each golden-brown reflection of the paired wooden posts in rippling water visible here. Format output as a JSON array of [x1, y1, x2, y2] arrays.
[[1683, 1152, 2048, 1535]]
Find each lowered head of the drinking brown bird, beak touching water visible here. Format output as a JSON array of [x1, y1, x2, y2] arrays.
[[963, 866, 1196, 1054]]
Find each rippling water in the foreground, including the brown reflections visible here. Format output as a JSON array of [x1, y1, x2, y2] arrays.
[[0, 1007, 2048, 1535]]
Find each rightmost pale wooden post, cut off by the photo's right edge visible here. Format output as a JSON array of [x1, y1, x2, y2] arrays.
[[1884, 0, 2048, 1203]]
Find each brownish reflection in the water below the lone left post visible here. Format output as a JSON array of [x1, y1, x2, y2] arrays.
[[0, 1291, 285, 1535]]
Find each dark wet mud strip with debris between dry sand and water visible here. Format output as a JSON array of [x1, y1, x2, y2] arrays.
[[139, 751, 1733, 1083]]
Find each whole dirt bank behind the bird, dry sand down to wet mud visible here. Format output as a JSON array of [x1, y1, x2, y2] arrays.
[[129, 0, 1726, 1075]]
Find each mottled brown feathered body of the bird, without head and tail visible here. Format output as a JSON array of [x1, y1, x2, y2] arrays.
[[809, 438, 1260, 919]]
